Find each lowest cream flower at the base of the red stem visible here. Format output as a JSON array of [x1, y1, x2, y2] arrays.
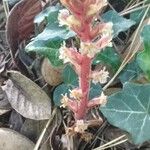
[[74, 120, 88, 133]]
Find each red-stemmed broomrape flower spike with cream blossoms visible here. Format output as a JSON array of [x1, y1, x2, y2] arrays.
[[58, 0, 113, 126]]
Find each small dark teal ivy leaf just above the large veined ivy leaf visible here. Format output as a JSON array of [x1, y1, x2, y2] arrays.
[[119, 60, 142, 83]]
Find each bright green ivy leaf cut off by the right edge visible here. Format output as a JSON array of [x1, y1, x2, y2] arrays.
[[137, 25, 150, 80]]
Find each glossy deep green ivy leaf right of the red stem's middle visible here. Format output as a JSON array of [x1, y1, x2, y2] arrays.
[[93, 47, 121, 72]]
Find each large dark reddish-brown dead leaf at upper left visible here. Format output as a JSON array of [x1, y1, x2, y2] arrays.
[[6, 0, 42, 56]]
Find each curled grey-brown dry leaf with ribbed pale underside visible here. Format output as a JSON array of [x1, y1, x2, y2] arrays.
[[3, 71, 51, 120]]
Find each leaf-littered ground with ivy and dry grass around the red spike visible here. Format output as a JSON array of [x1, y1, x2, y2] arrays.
[[0, 0, 150, 150]]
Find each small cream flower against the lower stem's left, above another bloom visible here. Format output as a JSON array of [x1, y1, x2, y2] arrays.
[[70, 88, 82, 100]]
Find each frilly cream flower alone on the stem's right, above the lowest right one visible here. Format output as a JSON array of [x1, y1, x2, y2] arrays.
[[91, 67, 109, 84]]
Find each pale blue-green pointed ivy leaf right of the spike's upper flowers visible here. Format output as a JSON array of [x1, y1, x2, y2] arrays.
[[102, 10, 136, 37]]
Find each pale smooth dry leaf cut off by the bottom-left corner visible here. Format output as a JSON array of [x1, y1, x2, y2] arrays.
[[0, 128, 34, 150]]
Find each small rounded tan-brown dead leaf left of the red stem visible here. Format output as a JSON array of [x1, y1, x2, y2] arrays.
[[41, 58, 63, 86]]
